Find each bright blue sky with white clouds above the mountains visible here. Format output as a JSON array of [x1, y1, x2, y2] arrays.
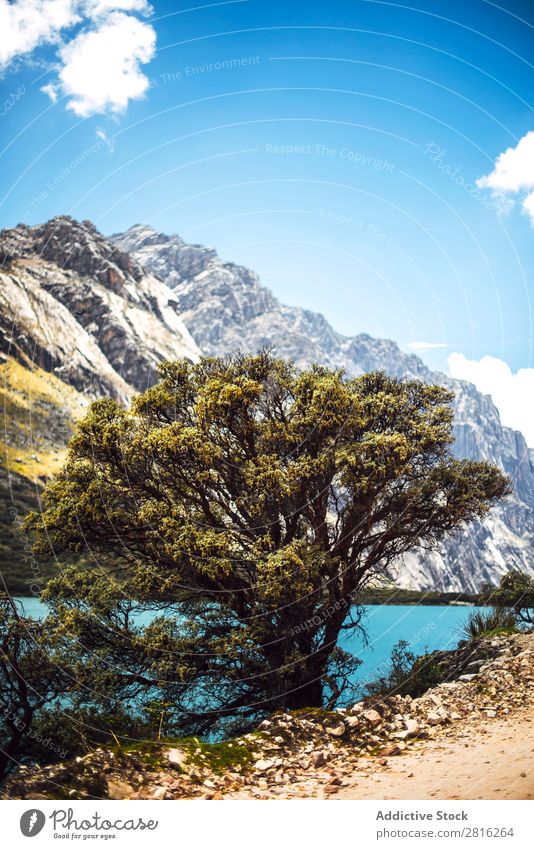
[[0, 0, 534, 444]]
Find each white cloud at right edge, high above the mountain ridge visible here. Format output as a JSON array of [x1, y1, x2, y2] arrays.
[[476, 131, 534, 226]]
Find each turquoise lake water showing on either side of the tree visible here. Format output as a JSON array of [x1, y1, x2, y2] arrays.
[[15, 598, 473, 687]]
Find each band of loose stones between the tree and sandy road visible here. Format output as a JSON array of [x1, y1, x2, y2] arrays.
[[0, 634, 534, 799]]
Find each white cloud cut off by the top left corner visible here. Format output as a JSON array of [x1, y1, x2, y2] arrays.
[[0, 0, 80, 70]]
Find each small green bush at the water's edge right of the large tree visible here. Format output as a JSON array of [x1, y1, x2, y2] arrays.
[[366, 640, 442, 699]]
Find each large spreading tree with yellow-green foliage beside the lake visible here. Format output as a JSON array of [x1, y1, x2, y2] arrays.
[[31, 352, 509, 731]]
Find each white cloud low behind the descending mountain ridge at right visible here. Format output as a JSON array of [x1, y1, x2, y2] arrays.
[[449, 353, 534, 448]]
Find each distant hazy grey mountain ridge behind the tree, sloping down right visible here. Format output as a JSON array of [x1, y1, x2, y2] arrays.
[[111, 225, 534, 591]]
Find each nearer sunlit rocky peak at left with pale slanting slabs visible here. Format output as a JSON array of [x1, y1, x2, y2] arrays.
[[0, 216, 200, 401]]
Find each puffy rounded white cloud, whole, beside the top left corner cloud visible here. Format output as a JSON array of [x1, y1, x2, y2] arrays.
[[53, 12, 156, 118]]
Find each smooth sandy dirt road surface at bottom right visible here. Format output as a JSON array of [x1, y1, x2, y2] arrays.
[[330, 712, 534, 799]]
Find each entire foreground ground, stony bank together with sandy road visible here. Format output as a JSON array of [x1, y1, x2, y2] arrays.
[[4, 633, 534, 799]]
